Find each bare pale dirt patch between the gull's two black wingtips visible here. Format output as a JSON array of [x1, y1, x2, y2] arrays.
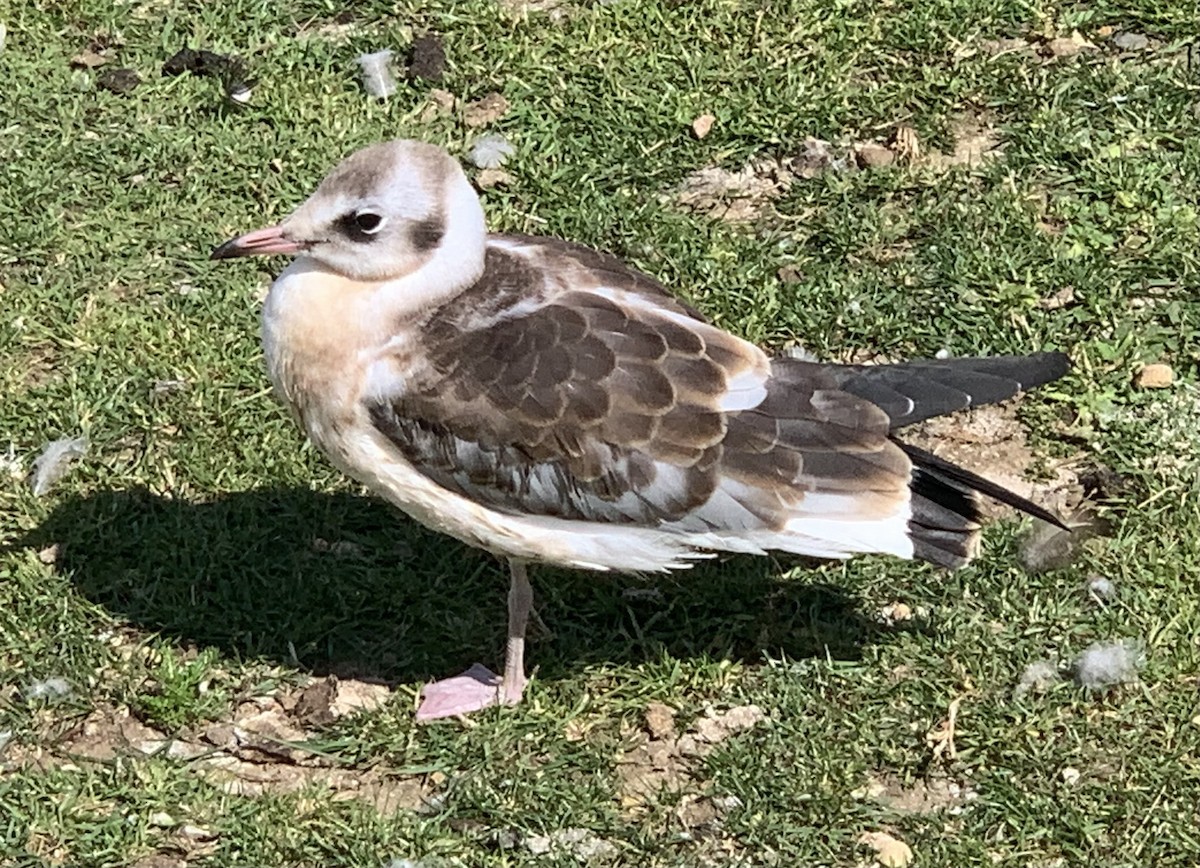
[[901, 402, 1084, 516]]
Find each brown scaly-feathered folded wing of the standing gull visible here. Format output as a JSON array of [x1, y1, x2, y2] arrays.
[[368, 241, 910, 532]]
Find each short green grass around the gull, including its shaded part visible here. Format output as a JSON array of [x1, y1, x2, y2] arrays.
[[0, 0, 1200, 868]]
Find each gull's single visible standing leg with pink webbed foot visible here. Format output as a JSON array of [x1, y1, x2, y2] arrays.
[[416, 561, 533, 720]]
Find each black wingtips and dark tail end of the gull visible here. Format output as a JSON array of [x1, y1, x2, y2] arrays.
[[839, 353, 1069, 568]]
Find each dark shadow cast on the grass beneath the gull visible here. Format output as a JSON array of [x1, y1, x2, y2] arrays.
[[18, 489, 902, 682]]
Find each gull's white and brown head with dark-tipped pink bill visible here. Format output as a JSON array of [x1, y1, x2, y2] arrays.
[[211, 140, 486, 281]]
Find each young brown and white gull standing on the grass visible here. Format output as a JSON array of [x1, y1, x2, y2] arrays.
[[212, 140, 1068, 720]]
